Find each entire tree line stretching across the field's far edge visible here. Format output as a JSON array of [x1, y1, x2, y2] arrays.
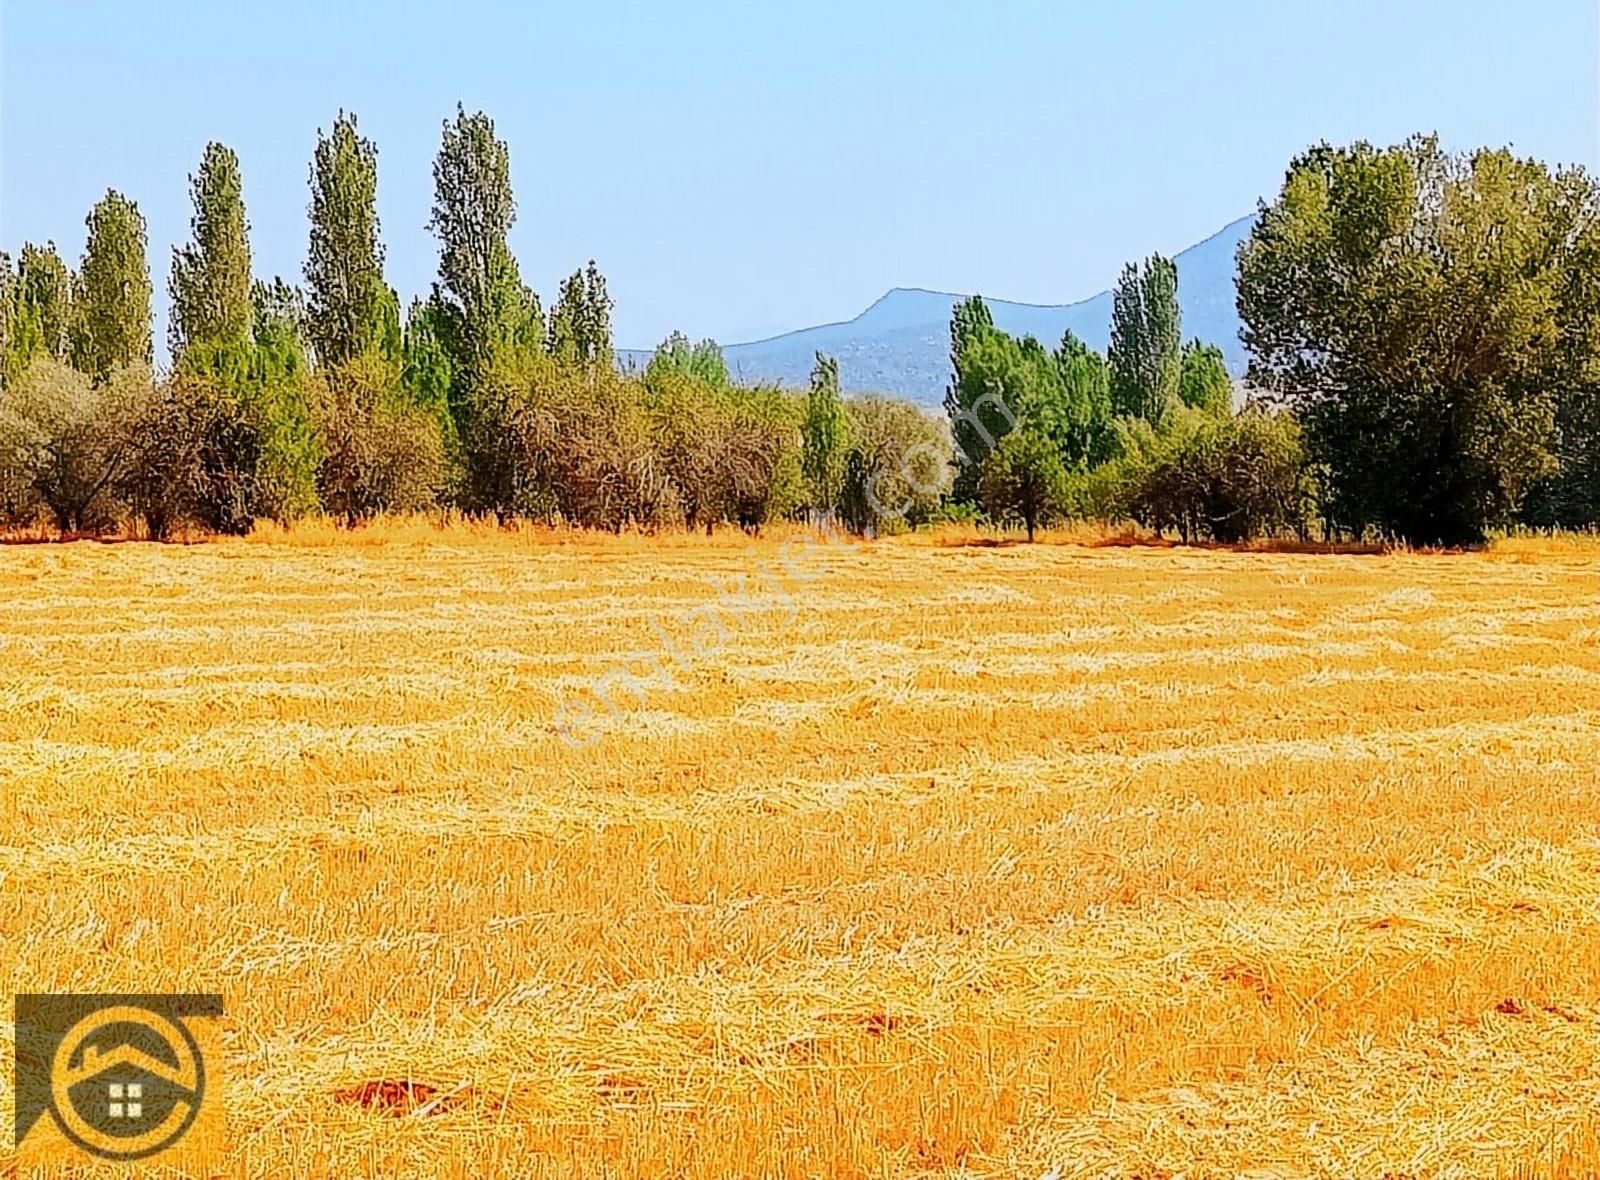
[[0, 118, 1600, 544]]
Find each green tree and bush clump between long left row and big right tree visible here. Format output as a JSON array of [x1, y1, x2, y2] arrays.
[[944, 256, 1286, 540]]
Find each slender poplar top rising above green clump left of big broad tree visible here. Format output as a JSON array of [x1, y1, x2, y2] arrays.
[[1109, 254, 1182, 425]]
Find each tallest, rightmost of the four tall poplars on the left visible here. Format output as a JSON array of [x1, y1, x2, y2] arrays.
[[429, 107, 544, 393]]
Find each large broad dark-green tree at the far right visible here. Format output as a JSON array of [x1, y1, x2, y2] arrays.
[[1238, 138, 1600, 544]]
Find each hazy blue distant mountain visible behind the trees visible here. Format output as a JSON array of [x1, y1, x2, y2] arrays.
[[624, 216, 1254, 406]]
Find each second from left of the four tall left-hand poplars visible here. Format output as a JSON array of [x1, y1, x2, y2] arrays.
[[170, 142, 254, 360]]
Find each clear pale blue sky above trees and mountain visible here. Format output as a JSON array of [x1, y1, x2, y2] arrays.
[[0, 0, 1600, 345]]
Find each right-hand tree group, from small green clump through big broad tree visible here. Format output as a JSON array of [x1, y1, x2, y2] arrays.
[[946, 138, 1600, 544]]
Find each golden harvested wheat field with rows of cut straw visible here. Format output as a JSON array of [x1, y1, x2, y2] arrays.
[[0, 523, 1600, 1180]]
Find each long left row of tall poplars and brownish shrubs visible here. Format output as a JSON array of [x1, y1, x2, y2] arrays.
[[0, 110, 949, 537]]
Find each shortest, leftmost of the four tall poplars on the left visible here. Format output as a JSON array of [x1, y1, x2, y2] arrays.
[[72, 190, 155, 382]]
